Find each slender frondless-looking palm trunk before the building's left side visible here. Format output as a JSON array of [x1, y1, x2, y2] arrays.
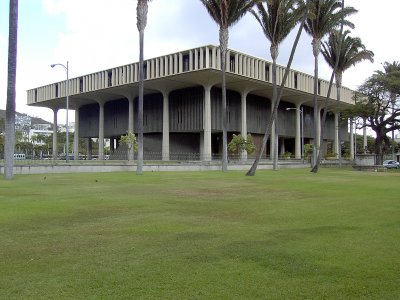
[[136, 0, 151, 175]]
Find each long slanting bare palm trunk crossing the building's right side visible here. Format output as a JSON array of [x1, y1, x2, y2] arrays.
[[246, 1, 311, 176]]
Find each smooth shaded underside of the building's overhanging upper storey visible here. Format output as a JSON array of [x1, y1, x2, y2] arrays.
[[28, 68, 351, 110]]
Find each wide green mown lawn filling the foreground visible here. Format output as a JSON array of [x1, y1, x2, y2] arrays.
[[0, 169, 400, 299]]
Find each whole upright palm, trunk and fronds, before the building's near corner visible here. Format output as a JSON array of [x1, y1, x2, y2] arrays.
[[200, 0, 258, 172]]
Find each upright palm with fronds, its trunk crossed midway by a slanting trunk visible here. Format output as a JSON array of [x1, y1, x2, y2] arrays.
[[251, 0, 301, 170]]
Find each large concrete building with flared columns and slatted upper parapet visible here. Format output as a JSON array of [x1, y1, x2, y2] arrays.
[[27, 45, 353, 161]]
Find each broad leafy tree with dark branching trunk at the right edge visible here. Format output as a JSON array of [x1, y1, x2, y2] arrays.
[[346, 71, 400, 165]]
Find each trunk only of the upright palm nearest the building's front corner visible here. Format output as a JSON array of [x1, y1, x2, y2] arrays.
[[219, 27, 229, 172]]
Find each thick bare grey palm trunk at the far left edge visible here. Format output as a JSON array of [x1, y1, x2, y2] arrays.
[[4, 0, 18, 179]]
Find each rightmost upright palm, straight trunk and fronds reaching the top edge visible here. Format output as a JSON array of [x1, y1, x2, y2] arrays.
[[305, 0, 357, 169]]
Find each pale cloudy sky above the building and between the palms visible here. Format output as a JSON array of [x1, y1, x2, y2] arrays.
[[0, 0, 400, 123]]
